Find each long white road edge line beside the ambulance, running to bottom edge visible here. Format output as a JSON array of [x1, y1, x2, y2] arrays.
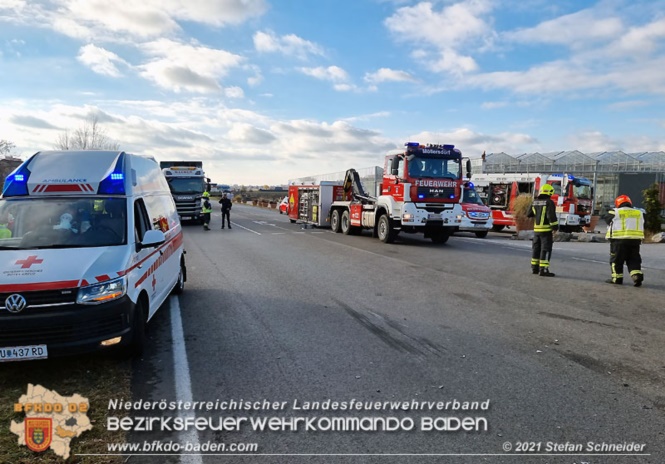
[[169, 295, 203, 464]]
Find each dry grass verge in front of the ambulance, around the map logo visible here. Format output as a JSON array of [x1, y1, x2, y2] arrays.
[[0, 356, 131, 464]]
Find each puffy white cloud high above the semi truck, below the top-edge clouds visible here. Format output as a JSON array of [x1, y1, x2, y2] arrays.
[[137, 39, 244, 93]]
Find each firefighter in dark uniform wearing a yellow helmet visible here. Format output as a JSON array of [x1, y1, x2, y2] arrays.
[[527, 184, 559, 277]]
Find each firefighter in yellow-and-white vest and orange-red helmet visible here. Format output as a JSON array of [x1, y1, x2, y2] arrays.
[[605, 195, 644, 287]]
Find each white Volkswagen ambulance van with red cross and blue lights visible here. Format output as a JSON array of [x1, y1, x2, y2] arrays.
[[0, 151, 187, 362]]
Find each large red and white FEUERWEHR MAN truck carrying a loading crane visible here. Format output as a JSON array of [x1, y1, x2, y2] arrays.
[[289, 142, 471, 243]]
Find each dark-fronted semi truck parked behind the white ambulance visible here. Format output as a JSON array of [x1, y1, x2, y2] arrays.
[[159, 161, 210, 224]]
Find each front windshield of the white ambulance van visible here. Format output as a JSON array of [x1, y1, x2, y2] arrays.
[[0, 196, 127, 249]]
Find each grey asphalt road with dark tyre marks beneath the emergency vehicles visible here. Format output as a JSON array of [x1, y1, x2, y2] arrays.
[[130, 205, 665, 464]]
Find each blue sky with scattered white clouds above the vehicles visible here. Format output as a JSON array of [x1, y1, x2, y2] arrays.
[[0, 0, 665, 185]]
